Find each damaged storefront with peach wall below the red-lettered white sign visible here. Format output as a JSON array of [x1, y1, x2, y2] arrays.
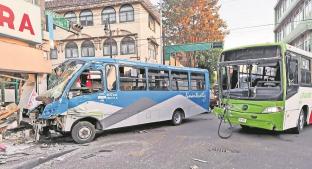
[[0, 0, 52, 105]]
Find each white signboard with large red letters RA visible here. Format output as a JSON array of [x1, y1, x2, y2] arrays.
[[0, 0, 42, 43]]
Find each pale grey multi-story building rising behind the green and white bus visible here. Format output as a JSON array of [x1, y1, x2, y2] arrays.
[[274, 0, 312, 52]]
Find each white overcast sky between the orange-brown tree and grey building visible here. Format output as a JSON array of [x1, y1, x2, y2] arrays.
[[152, 0, 277, 48]]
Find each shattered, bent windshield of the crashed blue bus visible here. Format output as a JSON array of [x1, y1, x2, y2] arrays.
[[43, 60, 84, 99]]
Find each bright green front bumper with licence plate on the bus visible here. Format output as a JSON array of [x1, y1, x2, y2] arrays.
[[214, 108, 284, 131]]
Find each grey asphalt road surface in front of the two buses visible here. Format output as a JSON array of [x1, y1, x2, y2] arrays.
[[5, 114, 312, 169]]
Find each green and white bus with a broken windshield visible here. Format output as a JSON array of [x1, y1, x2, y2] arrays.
[[214, 43, 312, 133]]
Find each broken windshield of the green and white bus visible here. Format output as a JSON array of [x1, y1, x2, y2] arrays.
[[220, 60, 282, 100]]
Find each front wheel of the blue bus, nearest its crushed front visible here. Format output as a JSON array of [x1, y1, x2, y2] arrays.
[[71, 121, 96, 144]]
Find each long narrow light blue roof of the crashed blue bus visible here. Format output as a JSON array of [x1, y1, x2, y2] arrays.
[[69, 57, 208, 72]]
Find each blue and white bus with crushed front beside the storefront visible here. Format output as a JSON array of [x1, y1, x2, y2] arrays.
[[30, 58, 210, 143]]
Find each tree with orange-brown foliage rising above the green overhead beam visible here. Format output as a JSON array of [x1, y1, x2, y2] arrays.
[[162, 0, 227, 45]]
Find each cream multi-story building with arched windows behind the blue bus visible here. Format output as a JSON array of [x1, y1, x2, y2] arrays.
[[46, 0, 162, 65]]
